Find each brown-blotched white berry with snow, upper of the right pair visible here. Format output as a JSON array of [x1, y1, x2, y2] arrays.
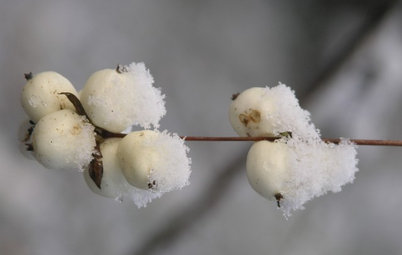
[[229, 83, 319, 138]]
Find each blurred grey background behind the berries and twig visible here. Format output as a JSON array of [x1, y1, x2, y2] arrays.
[[0, 0, 402, 255]]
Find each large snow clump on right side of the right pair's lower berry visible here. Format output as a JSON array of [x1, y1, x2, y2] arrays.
[[277, 137, 358, 216]]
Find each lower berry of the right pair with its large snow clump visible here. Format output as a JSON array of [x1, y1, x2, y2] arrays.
[[247, 130, 358, 216]]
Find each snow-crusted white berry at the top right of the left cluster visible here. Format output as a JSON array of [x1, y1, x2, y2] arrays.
[[80, 63, 166, 132]]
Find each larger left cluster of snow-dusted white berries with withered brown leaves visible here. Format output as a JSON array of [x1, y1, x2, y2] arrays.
[[21, 63, 191, 207]]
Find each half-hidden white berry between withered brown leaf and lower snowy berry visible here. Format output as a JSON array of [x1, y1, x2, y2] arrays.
[[83, 138, 127, 199]]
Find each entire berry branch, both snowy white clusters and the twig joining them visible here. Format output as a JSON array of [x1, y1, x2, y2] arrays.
[[21, 63, 402, 216]]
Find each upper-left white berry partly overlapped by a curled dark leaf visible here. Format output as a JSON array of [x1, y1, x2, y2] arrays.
[[21, 72, 77, 123]]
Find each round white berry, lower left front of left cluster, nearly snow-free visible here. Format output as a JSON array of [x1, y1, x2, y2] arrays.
[[32, 109, 95, 170]]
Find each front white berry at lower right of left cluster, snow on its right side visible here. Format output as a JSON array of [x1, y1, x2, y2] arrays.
[[117, 130, 191, 192]]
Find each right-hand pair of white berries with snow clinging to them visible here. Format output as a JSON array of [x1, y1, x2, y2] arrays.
[[229, 84, 358, 216]]
